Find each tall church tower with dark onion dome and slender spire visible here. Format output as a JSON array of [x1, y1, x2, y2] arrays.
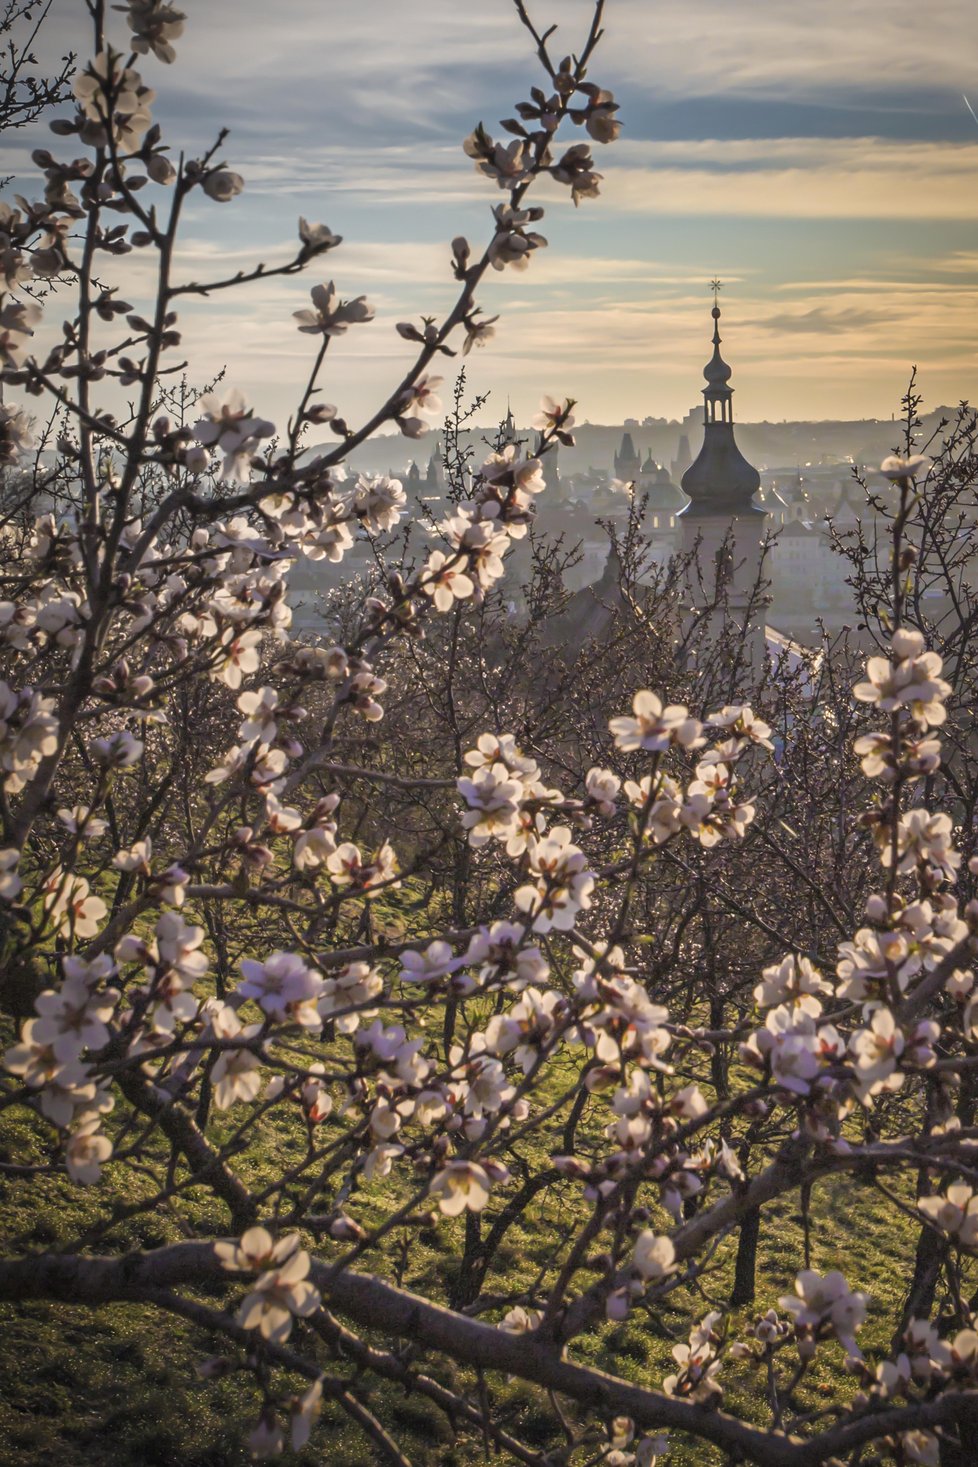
[[680, 290, 767, 669]]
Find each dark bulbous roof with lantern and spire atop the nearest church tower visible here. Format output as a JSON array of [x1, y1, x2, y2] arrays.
[[682, 301, 764, 519]]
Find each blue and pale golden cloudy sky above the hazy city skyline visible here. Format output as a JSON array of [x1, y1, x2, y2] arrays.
[[11, 0, 978, 424]]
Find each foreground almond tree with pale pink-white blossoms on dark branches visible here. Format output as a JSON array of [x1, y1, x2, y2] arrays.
[[0, 0, 978, 1467]]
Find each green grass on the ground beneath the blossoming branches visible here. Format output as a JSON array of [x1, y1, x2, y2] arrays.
[[0, 968, 916, 1467]]
